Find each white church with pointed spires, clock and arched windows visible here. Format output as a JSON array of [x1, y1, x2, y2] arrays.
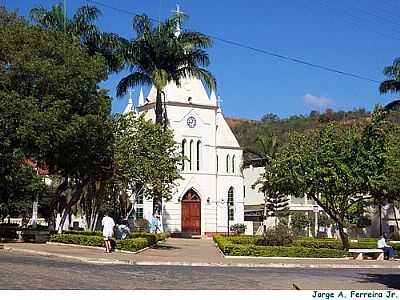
[[125, 78, 244, 236]]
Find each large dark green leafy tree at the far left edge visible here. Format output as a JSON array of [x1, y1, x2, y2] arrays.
[[0, 9, 113, 232]]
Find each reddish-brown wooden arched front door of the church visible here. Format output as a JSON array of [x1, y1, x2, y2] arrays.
[[181, 189, 201, 234]]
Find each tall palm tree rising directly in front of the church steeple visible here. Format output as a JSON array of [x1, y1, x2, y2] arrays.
[[117, 13, 216, 125]]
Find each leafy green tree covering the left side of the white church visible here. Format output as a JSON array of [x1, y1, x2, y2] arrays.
[[114, 113, 182, 217]]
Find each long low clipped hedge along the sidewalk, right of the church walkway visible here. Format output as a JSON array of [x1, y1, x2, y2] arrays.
[[214, 236, 349, 258]]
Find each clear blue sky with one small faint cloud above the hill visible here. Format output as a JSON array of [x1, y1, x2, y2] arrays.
[[0, 0, 400, 119]]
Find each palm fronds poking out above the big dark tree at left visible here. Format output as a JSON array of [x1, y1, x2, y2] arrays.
[[30, 3, 127, 72]]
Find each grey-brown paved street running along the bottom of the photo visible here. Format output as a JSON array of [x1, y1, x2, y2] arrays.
[[0, 250, 400, 289]]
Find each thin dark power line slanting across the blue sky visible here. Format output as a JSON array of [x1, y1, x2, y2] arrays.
[[86, 0, 380, 83]]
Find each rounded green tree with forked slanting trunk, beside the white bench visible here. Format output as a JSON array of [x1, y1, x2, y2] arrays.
[[255, 118, 379, 249]]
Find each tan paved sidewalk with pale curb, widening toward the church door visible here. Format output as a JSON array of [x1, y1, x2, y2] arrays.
[[0, 238, 400, 269]]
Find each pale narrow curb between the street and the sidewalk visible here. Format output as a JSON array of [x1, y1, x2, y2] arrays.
[[4, 247, 400, 269]]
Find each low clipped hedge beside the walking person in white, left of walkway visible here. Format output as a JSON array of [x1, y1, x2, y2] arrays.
[[49, 233, 150, 251]]
